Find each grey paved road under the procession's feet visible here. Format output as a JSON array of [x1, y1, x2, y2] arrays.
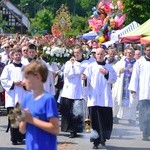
[[0, 112, 150, 150]]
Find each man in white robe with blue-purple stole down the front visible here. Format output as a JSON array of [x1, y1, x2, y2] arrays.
[[112, 48, 137, 125]]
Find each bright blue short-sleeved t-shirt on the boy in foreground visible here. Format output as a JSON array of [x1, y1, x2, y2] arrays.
[[22, 93, 58, 150]]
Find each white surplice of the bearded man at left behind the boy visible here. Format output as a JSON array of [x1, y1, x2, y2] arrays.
[[0, 64, 27, 108]]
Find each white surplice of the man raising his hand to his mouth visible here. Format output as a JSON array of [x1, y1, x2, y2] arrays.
[[61, 60, 89, 99]]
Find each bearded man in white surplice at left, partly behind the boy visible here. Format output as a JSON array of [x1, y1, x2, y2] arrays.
[[0, 49, 27, 145]]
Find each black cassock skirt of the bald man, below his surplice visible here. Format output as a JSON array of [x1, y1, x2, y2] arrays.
[[89, 106, 113, 143]]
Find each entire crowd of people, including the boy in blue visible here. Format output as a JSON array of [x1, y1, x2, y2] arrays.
[[0, 34, 150, 150]]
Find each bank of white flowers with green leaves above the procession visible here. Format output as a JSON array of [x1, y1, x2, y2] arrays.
[[42, 45, 73, 64]]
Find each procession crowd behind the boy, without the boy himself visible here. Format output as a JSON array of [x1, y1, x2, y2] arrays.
[[0, 34, 150, 149]]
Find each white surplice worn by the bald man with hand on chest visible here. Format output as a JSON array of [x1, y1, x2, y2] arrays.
[[84, 62, 117, 107]]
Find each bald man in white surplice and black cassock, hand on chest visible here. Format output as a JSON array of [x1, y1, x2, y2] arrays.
[[82, 48, 117, 149]]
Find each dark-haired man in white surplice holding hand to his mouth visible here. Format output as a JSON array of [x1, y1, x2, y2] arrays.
[[60, 45, 89, 138]]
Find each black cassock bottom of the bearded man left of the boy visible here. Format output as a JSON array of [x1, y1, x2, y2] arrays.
[[6, 107, 25, 142]]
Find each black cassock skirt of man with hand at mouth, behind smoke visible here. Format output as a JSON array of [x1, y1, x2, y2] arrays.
[[60, 98, 84, 133]]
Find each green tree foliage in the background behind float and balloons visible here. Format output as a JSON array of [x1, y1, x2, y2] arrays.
[[8, 0, 150, 33]]
